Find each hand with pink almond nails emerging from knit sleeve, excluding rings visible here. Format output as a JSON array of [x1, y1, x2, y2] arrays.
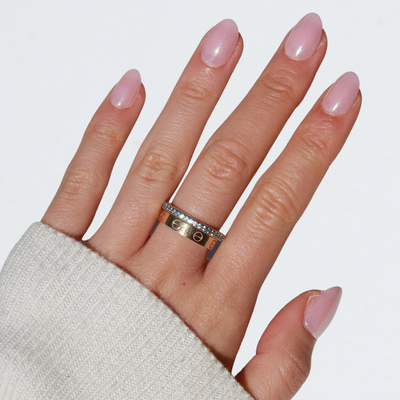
[[42, 14, 361, 400]]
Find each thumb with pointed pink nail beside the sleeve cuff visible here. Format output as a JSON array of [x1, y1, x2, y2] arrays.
[[236, 287, 342, 400]]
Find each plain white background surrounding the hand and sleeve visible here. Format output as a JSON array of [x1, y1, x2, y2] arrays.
[[0, 0, 400, 400]]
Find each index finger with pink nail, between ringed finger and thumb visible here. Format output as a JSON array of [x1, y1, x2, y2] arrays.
[[203, 73, 361, 349]]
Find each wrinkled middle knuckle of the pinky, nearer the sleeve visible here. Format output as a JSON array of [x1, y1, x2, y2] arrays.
[[62, 167, 105, 197]]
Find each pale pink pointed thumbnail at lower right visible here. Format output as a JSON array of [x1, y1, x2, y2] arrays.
[[304, 286, 342, 339]]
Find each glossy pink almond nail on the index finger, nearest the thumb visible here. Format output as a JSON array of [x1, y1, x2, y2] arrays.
[[322, 72, 360, 115]]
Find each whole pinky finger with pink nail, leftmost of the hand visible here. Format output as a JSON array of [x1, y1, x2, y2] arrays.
[[42, 70, 145, 240]]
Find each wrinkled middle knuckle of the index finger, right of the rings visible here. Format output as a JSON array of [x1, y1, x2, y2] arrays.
[[253, 178, 300, 231]]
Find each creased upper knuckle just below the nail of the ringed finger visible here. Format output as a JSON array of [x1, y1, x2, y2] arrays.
[[260, 70, 300, 106]]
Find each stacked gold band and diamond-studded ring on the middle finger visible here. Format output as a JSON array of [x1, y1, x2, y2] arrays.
[[158, 203, 225, 250]]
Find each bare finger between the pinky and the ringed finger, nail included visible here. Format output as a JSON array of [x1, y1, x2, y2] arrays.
[[90, 20, 243, 262]]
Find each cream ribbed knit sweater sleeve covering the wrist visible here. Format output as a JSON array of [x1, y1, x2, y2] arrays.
[[0, 222, 251, 400]]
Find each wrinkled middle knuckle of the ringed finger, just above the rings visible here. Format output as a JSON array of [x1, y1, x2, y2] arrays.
[[204, 139, 249, 186]]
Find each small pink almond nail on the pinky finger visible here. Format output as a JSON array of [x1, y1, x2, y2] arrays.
[[111, 69, 142, 108]]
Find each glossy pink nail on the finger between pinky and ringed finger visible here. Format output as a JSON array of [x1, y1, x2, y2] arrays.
[[201, 19, 239, 68]]
